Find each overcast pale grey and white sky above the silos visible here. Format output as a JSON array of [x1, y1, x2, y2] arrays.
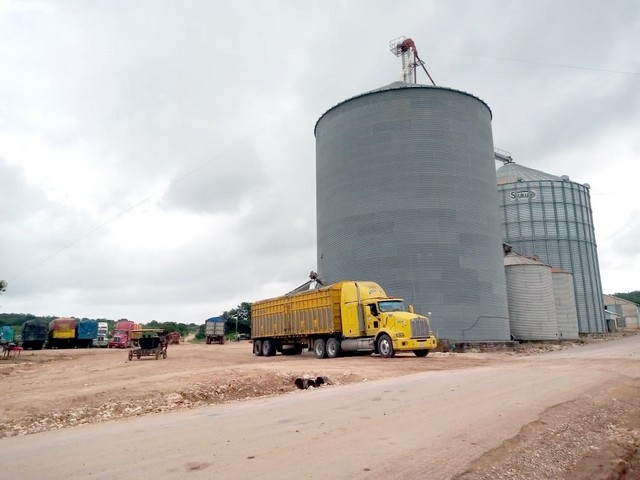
[[0, 0, 640, 323]]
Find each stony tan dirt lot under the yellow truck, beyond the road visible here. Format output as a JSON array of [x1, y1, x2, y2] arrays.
[[0, 341, 504, 437]]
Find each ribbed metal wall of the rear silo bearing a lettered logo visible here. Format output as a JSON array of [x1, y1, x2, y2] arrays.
[[498, 180, 607, 333]]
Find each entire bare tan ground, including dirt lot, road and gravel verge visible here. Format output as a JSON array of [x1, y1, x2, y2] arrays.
[[0, 336, 640, 479]]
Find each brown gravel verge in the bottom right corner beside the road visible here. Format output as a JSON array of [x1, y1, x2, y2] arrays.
[[456, 381, 640, 480]]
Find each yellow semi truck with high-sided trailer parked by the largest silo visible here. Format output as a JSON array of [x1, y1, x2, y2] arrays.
[[251, 281, 437, 358]]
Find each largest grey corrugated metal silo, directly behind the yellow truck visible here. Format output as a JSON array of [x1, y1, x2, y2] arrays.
[[316, 86, 509, 341]]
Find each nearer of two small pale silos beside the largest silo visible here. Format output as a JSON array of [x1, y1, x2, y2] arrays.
[[504, 253, 559, 340]]
